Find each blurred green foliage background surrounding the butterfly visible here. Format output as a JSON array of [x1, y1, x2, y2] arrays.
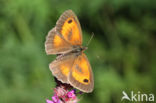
[[0, 0, 156, 103]]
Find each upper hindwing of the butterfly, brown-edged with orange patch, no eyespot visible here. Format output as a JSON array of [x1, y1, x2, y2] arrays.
[[45, 28, 72, 54]]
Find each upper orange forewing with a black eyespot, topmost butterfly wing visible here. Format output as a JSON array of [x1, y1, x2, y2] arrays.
[[56, 10, 82, 45]]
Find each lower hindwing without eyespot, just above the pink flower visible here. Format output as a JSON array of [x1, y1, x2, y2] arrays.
[[49, 55, 75, 84]]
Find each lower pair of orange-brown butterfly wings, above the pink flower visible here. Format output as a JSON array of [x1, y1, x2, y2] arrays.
[[49, 50, 94, 93]]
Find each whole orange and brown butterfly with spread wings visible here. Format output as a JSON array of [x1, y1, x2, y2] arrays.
[[45, 10, 94, 93]]
